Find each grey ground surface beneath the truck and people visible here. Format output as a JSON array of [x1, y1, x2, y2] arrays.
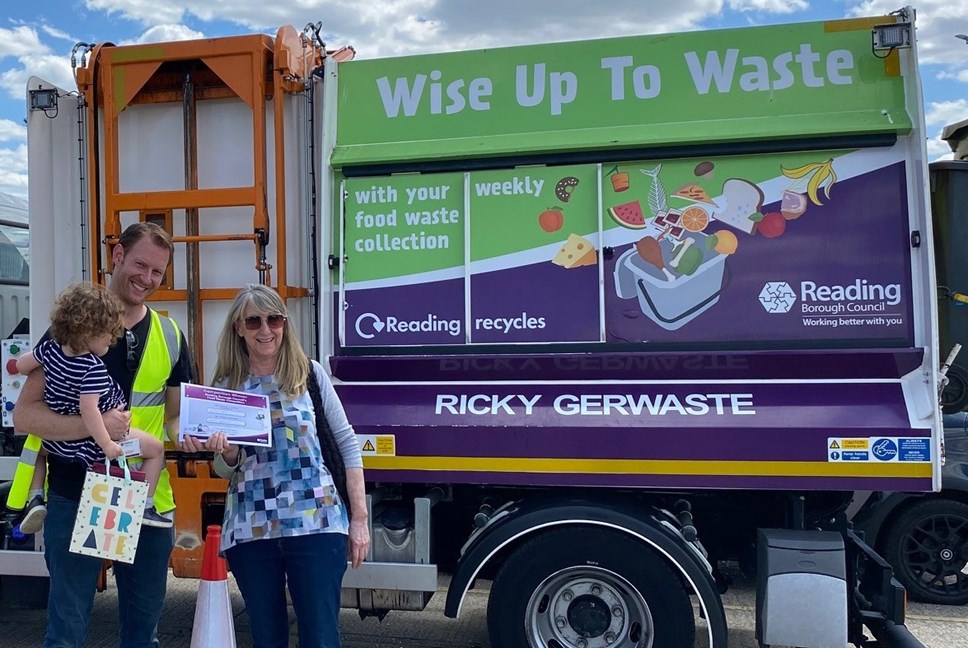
[[0, 575, 968, 648]]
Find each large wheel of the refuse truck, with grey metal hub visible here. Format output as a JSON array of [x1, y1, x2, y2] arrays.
[[487, 527, 696, 648]]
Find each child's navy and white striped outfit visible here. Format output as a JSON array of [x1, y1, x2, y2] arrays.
[[33, 338, 127, 466]]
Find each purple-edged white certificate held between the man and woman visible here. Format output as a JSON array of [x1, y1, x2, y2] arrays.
[[178, 383, 272, 446]]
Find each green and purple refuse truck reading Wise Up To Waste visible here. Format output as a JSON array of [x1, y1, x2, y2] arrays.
[[7, 9, 943, 648]]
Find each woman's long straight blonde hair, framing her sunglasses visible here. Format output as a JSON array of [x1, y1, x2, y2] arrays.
[[212, 284, 309, 398]]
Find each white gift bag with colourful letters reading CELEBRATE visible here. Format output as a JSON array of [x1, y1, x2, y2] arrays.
[[70, 456, 148, 564]]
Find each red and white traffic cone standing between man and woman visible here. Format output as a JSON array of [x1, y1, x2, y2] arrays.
[[191, 525, 235, 648]]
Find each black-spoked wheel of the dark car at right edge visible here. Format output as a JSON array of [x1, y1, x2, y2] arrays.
[[883, 499, 968, 605]]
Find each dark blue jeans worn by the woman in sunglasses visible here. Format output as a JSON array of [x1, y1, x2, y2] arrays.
[[225, 533, 346, 648]]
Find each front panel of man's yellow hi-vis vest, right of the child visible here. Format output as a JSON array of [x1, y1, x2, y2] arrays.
[[130, 308, 182, 513]]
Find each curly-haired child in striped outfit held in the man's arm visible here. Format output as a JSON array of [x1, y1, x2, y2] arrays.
[[17, 283, 172, 533]]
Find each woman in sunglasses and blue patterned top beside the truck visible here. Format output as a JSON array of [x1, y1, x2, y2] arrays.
[[186, 285, 370, 648]]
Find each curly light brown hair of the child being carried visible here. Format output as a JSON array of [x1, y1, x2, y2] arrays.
[[50, 282, 124, 353]]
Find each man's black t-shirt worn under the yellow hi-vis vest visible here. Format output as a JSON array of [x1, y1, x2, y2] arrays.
[[44, 313, 192, 500]]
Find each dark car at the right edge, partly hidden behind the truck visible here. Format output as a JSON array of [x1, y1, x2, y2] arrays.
[[854, 412, 968, 605]]
